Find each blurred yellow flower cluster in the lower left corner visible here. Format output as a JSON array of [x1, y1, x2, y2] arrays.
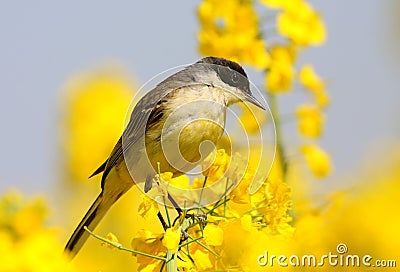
[[0, 192, 67, 272]]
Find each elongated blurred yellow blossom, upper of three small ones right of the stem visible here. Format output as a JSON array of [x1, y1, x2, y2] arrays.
[[299, 65, 330, 108]]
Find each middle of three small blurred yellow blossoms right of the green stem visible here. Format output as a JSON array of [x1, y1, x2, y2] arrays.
[[296, 105, 325, 138]]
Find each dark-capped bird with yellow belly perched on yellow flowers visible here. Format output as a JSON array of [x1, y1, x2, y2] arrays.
[[64, 56, 266, 259]]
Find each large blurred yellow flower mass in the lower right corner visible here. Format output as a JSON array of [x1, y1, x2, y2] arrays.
[[288, 149, 400, 271]]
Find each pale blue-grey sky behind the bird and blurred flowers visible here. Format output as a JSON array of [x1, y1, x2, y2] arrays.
[[0, 0, 400, 198]]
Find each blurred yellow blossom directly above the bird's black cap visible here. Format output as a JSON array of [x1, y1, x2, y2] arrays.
[[198, 0, 269, 69]]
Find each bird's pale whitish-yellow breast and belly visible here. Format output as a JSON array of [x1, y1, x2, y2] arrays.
[[146, 86, 226, 175]]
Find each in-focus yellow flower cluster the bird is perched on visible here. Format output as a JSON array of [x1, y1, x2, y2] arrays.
[[127, 150, 294, 271]]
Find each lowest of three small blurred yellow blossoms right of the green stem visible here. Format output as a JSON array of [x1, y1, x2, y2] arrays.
[[300, 145, 332, 178]]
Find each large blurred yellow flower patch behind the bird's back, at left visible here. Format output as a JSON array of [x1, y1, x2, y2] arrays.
[[62, 65, 136, 181]]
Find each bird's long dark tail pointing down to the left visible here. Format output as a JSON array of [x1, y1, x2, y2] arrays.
[[64, 193, 111, 259]]
